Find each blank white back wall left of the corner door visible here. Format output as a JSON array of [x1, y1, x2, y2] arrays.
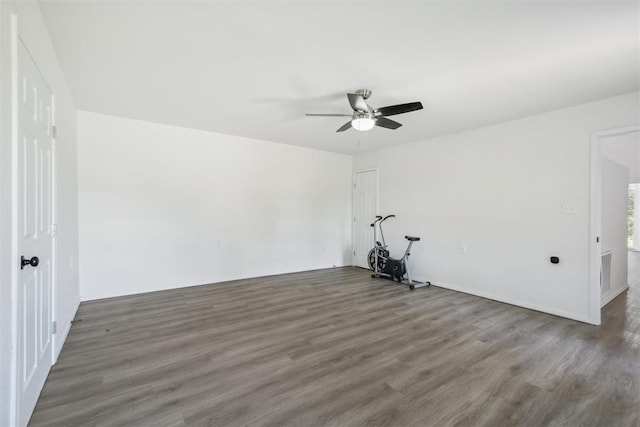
[[78, 111, 352, 300]]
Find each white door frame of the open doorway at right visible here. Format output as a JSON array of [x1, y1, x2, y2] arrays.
[[589, 124, 640, 325]]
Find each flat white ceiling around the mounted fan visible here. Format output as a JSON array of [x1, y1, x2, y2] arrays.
[[40, 0, 640, 153]]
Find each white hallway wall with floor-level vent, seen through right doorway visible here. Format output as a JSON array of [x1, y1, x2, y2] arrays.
[[600, 159, 629, 305]]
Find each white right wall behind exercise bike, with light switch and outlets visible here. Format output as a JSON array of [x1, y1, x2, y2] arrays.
[[354, 92, 640, 321]]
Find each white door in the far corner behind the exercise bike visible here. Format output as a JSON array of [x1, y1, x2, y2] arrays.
[[353, 170, 378, 268]]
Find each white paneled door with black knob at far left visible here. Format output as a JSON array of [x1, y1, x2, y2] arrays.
[[14, 39, 53, 425]]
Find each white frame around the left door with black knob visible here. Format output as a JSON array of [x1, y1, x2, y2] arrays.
[[9, 12, 58, 425]]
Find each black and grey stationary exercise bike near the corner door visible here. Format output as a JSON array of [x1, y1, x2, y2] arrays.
[[367, 215, 431, 290]]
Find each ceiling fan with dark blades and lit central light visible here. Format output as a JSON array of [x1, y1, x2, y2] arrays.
[[305, 89, 422, 132]]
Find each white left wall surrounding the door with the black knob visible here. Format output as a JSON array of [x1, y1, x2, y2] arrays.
[[0, 1, 79, 426]]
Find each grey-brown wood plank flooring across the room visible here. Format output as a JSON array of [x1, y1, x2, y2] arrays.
[[30, 267, 640, 426]]
